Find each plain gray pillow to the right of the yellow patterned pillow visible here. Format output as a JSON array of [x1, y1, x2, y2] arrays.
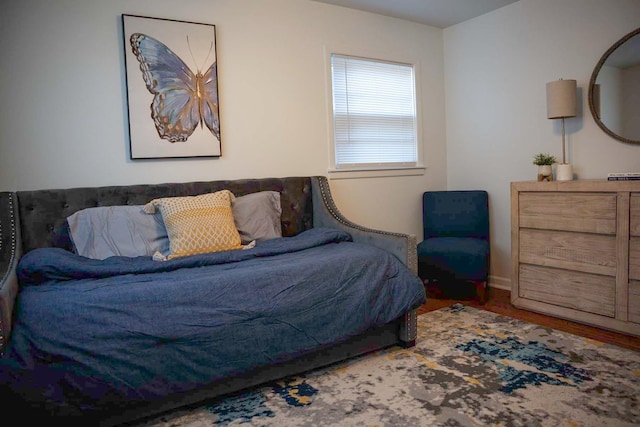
[[231, 191, 282, 245]]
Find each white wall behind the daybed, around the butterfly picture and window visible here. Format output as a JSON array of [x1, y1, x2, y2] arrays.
[[0, 0, 446, 241]]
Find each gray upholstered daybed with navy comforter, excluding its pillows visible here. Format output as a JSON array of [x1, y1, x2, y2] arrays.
[[0, 177, 425, 425]]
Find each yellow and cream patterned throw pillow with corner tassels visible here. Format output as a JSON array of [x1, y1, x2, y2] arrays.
[[144, 190, 242, 259]]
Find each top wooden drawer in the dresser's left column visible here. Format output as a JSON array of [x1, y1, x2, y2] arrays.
[[518, 192, 616, 235]]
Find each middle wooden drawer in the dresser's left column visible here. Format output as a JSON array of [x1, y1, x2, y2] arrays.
[[519, 228, 617, 276]]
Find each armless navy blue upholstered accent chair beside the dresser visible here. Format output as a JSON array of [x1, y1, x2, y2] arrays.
[[417, 190, 490, 304]]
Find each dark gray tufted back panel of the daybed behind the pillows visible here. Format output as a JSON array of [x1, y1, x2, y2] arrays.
[[16, 177, 313, 253]]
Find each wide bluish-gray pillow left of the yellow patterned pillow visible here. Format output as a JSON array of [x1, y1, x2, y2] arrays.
[[67, 206, 169, 259]]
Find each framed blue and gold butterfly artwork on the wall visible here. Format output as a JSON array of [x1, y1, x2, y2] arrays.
[[122, 14, 221, 159]]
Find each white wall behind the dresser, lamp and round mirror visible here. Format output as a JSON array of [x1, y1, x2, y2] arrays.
[[444, 0, 640, 290]]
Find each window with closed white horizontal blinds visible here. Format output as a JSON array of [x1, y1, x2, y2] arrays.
[[331, 54, 418, 170]]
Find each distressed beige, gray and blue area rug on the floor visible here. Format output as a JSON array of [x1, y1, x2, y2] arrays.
[[136, 304, 640, 427]]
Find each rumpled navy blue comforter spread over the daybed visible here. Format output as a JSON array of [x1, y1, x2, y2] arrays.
[[0, 228, 425, 416]]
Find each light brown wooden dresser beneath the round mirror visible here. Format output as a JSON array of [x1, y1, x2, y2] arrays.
[[511, 180, 640, 336]]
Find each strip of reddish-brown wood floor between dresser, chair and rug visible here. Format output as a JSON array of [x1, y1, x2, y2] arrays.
[[418, 284, 640, 352]]
